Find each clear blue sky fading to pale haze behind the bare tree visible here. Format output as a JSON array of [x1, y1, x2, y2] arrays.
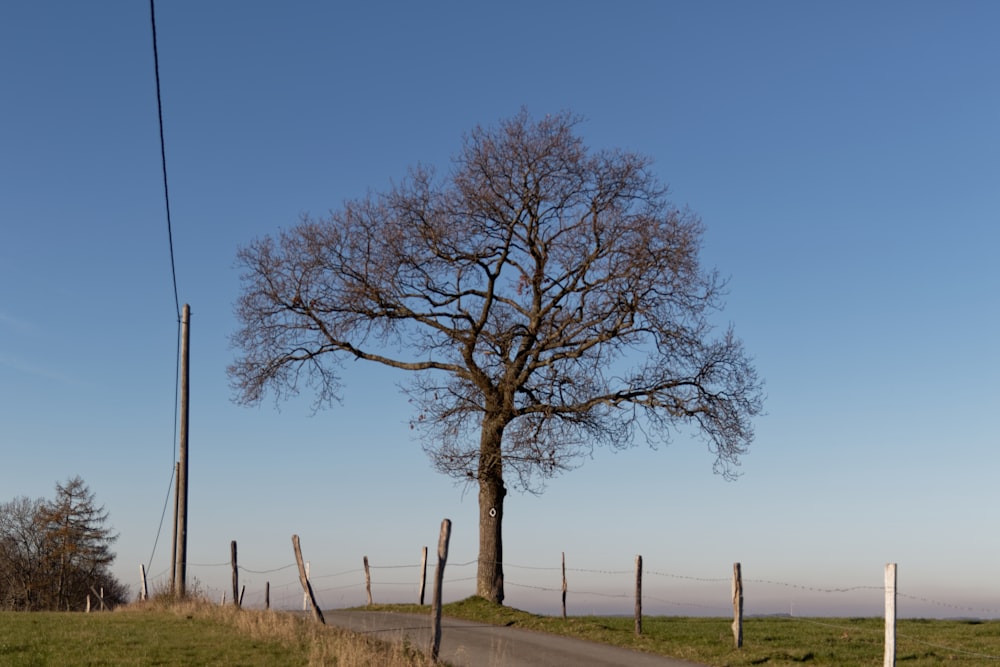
[[0, 0, 1000, 616]]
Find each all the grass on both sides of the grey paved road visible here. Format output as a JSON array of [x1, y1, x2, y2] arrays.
[[0, 598, 1000, 667]]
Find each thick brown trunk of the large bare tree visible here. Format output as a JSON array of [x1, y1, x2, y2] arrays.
[[476, 416, 507, 604]]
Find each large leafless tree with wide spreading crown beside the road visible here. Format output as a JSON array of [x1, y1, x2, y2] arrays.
[[229, 110, 762, 602]]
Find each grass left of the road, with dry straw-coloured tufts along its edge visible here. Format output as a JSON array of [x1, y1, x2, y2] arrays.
[[0, 602, 430, 667]]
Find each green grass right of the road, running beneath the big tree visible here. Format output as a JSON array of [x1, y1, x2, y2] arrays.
[[364, 597, 1000, 667]]
